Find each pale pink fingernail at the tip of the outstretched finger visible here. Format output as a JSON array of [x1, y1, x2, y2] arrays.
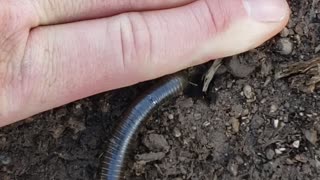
[[243, 0, 288, 22]]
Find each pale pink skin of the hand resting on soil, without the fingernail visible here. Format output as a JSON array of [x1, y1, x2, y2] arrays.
[[0, 0, 290, 127]]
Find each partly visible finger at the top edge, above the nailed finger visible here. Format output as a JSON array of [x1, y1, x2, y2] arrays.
[[30, 0, 193, 25]]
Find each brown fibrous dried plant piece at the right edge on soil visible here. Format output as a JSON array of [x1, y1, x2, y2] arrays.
[[275, 57, 320, 93]]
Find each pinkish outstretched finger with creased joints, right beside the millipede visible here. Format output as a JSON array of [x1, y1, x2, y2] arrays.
[[1, 0, 289, 125]]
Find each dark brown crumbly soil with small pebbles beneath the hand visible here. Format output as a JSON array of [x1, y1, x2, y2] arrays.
[[0, 0, 320, 180]]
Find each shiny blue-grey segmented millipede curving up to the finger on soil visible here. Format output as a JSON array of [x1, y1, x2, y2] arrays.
[[99, 73, 188, 180]]
